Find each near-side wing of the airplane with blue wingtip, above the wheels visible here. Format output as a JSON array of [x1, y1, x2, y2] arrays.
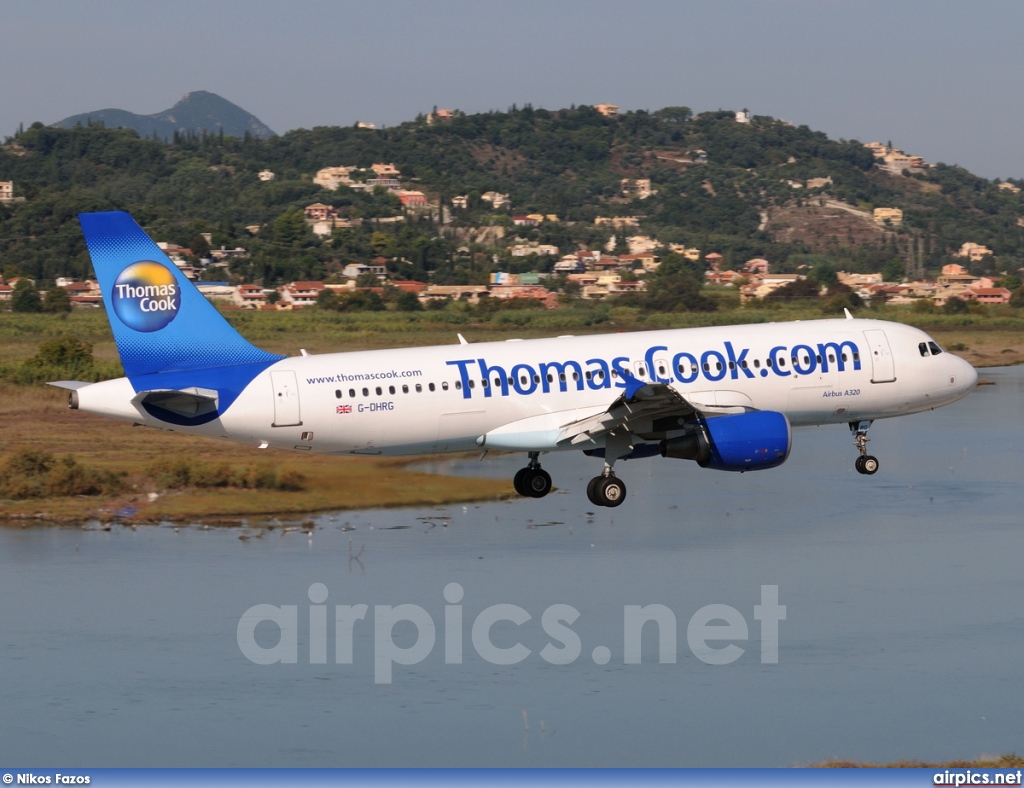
[[557, 377, 700, 448]]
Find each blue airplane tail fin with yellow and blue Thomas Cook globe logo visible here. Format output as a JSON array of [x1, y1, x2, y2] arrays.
[[79, 211, 284, 410]]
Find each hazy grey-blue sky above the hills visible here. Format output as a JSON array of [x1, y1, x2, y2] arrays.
[[0, 0, 1024, 178]]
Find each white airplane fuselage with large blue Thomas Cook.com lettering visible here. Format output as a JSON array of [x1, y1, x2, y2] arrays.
[[78, 319, 977, 454]]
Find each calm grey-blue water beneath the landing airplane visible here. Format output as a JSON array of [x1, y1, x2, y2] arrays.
[[0, 367, 1024, 767]]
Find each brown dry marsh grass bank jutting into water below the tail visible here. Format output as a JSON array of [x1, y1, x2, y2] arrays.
[[0, 384, 512, 522]]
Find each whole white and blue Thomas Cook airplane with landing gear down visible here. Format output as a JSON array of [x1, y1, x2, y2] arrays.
[[51, 212, 978, 507]]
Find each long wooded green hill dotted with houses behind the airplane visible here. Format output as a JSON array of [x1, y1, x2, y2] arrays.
[[0, 102, 1024, 284]]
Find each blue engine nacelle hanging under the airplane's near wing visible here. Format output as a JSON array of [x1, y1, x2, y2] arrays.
[[660, 410, 793, 472]]
